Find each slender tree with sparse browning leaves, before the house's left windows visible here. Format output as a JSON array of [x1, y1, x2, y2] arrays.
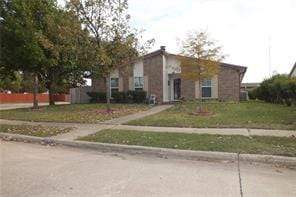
[[68, 0, 145, 112]]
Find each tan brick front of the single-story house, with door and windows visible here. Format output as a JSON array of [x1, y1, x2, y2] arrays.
[[92, 46, 247, 103]]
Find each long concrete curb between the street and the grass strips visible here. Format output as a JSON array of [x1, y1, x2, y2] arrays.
[[0, 133, 296, 168]]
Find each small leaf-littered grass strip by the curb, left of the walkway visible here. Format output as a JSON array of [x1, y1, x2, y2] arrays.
[[0, 125, 72, 137]]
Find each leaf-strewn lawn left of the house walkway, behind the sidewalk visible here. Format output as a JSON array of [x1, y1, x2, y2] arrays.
[[0, 104, 149, 123]]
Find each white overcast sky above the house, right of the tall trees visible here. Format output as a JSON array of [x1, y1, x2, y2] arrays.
[[129, 0, 296, 82]]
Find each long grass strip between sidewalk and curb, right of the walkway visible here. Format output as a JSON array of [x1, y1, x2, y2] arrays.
[[79, 130, 296, 157]]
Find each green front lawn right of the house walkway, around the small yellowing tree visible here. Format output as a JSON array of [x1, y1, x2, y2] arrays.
[[127, 101, 296, 130]]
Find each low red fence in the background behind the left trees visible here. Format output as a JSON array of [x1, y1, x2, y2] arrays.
[[0, 93, 69, 103]]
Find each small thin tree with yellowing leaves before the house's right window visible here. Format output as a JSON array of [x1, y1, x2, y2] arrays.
[[178, 31, 224, 112]]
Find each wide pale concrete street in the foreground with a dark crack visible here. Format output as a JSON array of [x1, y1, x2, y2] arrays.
[[0, 141, 296, 197]]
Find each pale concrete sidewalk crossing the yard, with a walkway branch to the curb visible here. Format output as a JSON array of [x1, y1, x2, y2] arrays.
[[0, 117, 296, 140]]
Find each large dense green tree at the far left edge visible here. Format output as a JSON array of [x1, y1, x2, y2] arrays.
[[0, 0, 54, 110]]
